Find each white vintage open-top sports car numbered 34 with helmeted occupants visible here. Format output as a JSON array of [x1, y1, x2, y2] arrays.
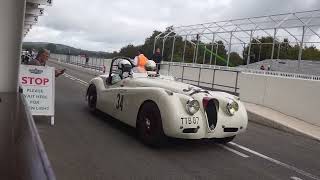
[[86, 57, 248, 145]]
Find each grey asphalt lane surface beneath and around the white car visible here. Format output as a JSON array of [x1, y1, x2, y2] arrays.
[[36, 61, 320, 180]]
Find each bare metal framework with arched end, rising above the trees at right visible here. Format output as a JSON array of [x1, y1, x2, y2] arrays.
[[153, 9, 320, 70]]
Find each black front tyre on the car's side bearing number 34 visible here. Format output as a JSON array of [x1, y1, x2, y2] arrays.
[[137, 102, 165, 147]]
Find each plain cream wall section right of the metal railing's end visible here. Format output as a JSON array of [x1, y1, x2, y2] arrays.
[[239, 73, 320, 127]]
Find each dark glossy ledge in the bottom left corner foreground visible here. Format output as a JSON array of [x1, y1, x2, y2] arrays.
[[0, 93, 55, 180]]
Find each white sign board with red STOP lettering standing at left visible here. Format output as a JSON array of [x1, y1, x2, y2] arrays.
[[19, 65, 55, 125]]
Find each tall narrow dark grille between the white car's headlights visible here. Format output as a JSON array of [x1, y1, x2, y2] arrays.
[[203, 97, 219, 130]]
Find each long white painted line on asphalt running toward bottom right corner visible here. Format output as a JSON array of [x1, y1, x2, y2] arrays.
[[229, 142, 320, 180]]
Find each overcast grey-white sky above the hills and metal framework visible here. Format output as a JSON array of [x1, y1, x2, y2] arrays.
[[24, 0, 320, 51]]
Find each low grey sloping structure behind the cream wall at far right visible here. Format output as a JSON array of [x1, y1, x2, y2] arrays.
[[239, 59, 320, 76]]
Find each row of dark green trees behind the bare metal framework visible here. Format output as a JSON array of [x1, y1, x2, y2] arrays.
[[117, 27, 320, 66]]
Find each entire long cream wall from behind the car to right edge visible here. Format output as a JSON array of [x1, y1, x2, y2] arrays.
[[160, 62, 320, 127]]
